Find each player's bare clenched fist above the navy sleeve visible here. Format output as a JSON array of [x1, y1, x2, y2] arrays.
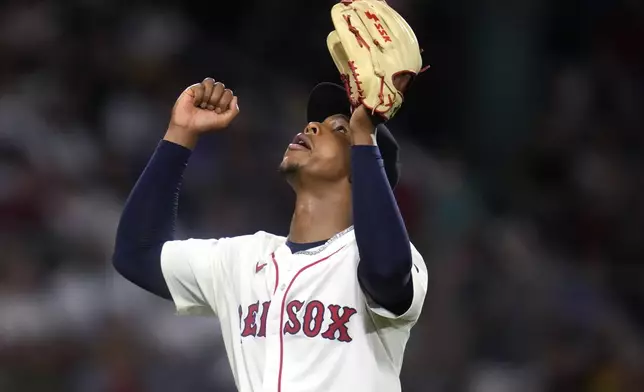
[[165, 78, 239, 148]]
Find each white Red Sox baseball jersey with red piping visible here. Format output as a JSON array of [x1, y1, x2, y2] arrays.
[[161, 227, 427, 392]]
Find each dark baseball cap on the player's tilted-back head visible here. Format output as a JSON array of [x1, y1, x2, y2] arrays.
[[306, 82, 400, 189]]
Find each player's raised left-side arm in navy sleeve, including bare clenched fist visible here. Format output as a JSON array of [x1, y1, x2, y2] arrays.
[[112, 78, 239, 299]]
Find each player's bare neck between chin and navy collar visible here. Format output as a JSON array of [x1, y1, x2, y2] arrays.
[[289, 190, 352, 243]]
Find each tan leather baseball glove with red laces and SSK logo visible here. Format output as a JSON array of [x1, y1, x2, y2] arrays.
[[327, 0, 428, 121]]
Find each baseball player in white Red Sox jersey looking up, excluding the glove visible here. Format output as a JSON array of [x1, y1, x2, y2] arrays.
[[113, 1, 427, 392]]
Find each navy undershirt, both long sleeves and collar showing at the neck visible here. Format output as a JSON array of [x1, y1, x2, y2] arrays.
[[112, 141, 413, 314]]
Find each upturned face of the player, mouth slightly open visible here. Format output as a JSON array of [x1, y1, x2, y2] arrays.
[[280, 115, 351, 186]]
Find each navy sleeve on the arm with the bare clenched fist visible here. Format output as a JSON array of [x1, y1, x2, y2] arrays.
[[112, 141, 190, 299]]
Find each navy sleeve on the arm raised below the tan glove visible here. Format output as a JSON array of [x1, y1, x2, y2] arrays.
[[351, 146, 413, 313]]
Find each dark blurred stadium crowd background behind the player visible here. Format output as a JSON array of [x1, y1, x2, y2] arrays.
[[0, 0, 644, 392]]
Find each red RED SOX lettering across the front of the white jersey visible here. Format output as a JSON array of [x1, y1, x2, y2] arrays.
[[240, 300, 357, 343]]
